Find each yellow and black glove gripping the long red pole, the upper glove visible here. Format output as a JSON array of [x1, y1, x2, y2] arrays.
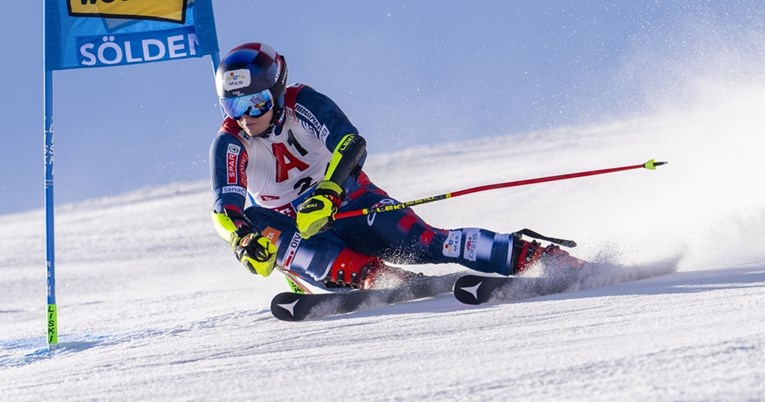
[[295, 180, 343, 239]]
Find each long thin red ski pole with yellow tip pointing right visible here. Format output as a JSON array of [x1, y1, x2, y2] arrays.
[[333, 159, 668, 220]]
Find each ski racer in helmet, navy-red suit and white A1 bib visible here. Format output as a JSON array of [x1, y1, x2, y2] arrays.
[[210, 43, 573, 288]]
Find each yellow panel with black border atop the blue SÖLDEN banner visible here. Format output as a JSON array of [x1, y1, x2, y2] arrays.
[[69, 0, 187, 23]]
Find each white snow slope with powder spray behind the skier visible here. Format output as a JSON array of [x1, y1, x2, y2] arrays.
[[0, 84, 765, 401]]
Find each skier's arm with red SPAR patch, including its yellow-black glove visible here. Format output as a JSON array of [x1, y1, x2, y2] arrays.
[[210, 133, 276, 276]]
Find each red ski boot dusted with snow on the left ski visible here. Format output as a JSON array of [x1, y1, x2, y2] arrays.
[[322, 248, 422, 289]]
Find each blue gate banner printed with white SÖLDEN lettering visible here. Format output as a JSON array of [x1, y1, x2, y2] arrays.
[[45, 0, 218, 71]]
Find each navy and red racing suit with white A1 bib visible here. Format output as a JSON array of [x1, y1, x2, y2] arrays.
[[210, 85, 513, 281]]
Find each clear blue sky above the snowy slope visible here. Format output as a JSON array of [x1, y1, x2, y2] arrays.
[[0, 0, 765, 215]]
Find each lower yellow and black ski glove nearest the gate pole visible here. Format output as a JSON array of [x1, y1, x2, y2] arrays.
[[231, 226, 276, 276]]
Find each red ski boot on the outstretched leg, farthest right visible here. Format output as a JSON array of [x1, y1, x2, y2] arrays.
[[510, 234, 586, 275]]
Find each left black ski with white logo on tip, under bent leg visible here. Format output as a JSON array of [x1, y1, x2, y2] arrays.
[[271, 272, 464, 321]]
